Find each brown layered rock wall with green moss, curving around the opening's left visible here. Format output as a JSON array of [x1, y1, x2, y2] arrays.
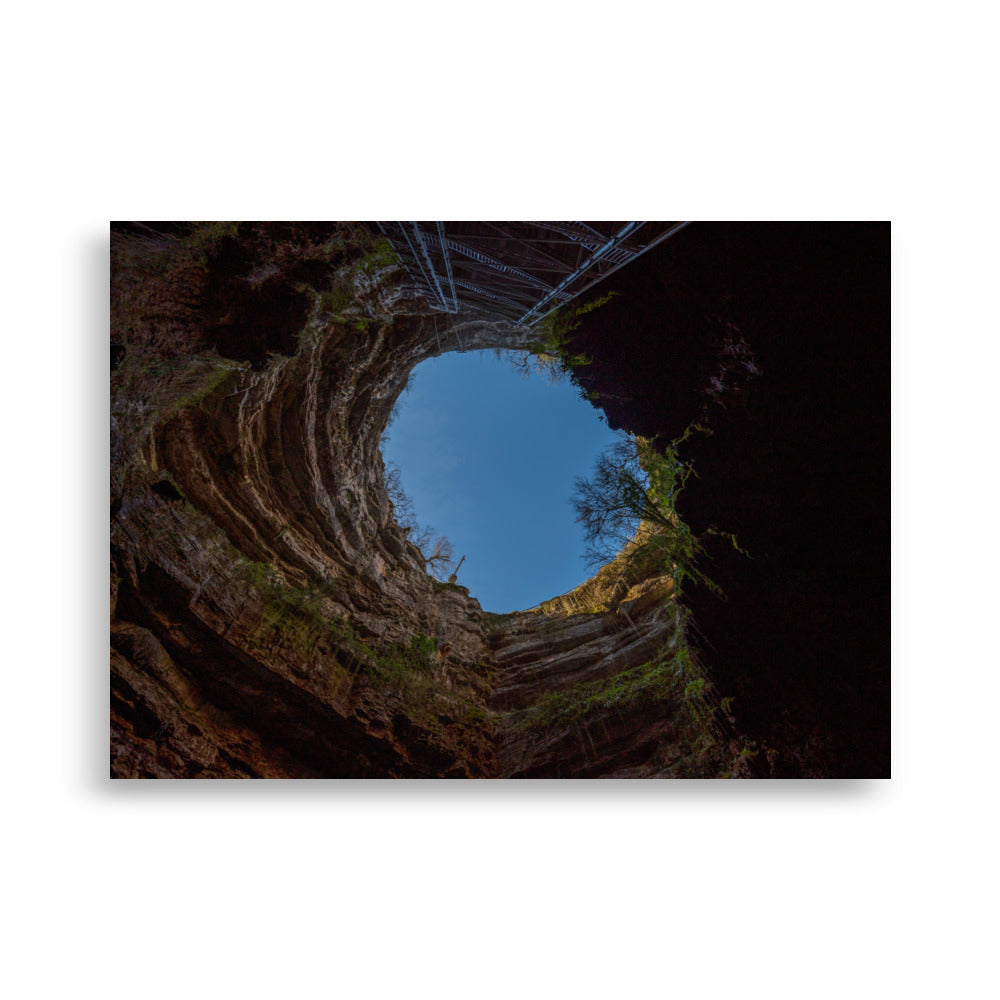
[[111, 224, 718, 777]]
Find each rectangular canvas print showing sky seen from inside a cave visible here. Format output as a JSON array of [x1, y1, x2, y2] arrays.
[[110, 221, 890, 779]]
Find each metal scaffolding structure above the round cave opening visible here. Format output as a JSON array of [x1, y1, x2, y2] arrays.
[[378, 222, 687, 326]]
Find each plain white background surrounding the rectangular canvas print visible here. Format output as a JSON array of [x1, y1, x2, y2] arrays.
[[0, 0, 1000, 998]]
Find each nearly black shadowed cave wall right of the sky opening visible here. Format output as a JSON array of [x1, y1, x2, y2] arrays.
[[572, 223, 890, 777]]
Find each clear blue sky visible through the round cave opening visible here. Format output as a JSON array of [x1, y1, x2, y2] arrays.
[[382, 351, 615, 613]]
